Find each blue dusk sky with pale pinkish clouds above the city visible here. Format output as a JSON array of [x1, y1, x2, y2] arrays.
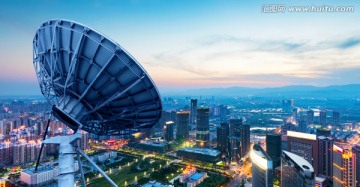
[[0, 0, 360, 95]]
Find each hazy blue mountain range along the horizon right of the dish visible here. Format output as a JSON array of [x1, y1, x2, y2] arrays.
[[162, 84, 360, 98]]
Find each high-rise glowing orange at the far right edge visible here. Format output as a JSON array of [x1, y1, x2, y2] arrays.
[[333, 144, 356, 187]]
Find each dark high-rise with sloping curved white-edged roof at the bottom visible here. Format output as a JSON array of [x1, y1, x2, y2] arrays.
[[281, 151, 315, 187]]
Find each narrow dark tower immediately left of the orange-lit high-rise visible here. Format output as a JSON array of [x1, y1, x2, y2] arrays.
[[318, 136, 334, 179]]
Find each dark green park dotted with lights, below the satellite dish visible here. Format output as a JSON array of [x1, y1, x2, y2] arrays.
[[85, 148, 229, 187]]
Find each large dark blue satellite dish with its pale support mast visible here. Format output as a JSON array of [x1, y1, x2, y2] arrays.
[[33, 20, 162, 187]]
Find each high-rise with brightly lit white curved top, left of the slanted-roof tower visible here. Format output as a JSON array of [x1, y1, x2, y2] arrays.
[[250, 144, 274, 187]]
